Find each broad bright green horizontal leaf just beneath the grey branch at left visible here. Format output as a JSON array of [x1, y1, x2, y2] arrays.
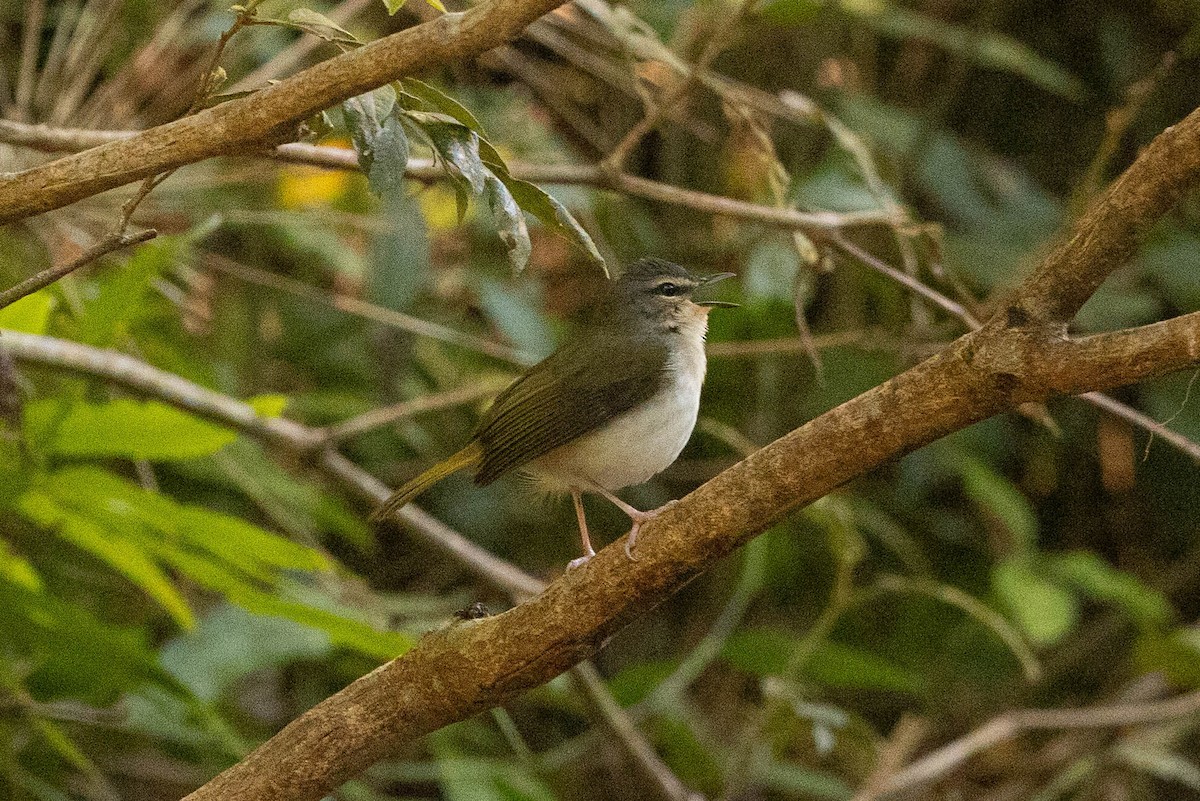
[[25, 398, 238, 462]]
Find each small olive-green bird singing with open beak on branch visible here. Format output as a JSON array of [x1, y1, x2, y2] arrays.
[[372, 259, 734, 567]]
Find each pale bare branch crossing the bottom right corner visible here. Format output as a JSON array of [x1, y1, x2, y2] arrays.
[[883, 691, 1200, 795]]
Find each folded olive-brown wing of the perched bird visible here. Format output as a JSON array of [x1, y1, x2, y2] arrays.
[[475, 333, 667, 484]]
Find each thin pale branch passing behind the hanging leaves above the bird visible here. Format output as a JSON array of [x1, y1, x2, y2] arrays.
[[0, 120, 893, 231]]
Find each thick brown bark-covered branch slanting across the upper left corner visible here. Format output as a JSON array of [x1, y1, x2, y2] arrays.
[[0, 0, 565, 223]]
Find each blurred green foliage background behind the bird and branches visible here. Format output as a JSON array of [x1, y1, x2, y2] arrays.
[[0, 0, 1200, 801]]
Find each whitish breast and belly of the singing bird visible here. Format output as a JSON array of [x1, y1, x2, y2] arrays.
[[530, 341, 706, 490]]
